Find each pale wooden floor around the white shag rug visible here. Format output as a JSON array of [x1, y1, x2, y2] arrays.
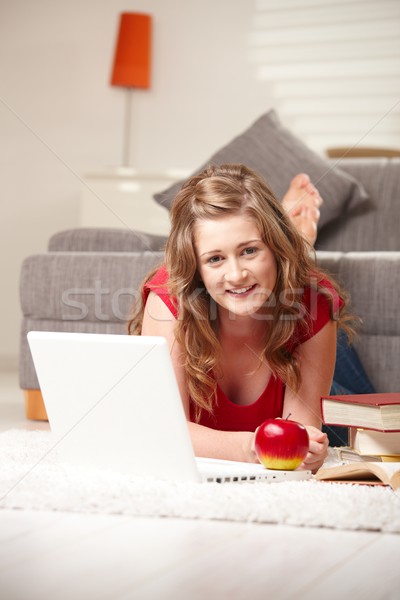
[[0, 373, 400, 600]]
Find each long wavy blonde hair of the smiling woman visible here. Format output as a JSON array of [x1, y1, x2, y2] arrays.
[[129, 164, 350, 420]]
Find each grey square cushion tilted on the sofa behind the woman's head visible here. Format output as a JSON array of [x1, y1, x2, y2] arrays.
[[154, 110, 368, 228]]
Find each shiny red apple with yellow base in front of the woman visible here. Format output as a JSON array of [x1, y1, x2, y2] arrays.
[[255, 419, 309, 471]]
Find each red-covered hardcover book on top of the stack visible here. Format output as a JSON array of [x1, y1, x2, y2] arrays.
[[321, 392, 400, 431]]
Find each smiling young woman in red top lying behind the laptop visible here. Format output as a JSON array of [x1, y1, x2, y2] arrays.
[[130, 165, 354, 471]]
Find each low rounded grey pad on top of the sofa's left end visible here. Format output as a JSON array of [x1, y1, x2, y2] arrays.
[[48, 227, 166, 252]]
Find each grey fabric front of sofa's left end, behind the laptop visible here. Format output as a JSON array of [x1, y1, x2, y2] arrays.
[[19, 252, 163, 389]]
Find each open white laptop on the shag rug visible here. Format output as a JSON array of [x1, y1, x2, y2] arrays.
[[28, 331, 311, 483]]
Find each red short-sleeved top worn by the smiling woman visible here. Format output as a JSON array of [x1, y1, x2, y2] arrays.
[[144, 266, 343, 431]]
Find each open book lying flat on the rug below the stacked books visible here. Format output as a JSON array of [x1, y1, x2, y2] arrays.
[[315, 462, 400, 490]]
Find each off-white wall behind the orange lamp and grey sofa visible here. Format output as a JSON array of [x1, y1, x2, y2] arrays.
[[0, 0, 400, 364]]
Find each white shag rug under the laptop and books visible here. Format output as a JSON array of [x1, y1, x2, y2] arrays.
[[0, 430, 400, 533]]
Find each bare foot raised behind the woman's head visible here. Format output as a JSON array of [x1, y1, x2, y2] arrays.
[[282, 173, 323, 245]]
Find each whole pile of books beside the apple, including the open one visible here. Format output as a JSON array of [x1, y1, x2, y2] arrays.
[[317, 393, 400, 488]]
